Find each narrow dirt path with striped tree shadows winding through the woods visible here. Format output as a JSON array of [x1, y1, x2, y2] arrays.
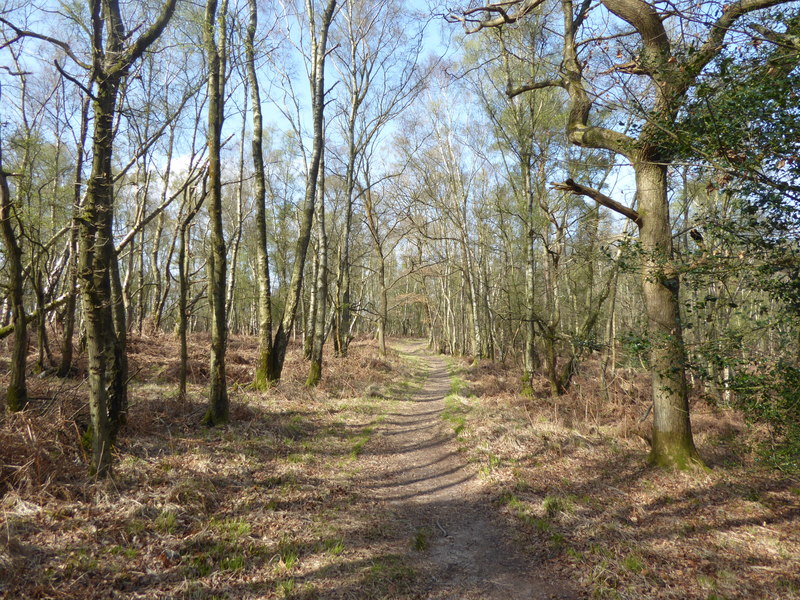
[[365, 344, 581, 600]]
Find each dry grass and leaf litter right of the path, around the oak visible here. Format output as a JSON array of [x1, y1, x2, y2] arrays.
[[450, 354, 800, 600]]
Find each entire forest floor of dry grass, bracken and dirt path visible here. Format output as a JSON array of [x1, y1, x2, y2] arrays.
[[0, 335, 800, 600]]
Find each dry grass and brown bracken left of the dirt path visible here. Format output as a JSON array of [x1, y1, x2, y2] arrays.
[[0, 336, 418, 600]]
